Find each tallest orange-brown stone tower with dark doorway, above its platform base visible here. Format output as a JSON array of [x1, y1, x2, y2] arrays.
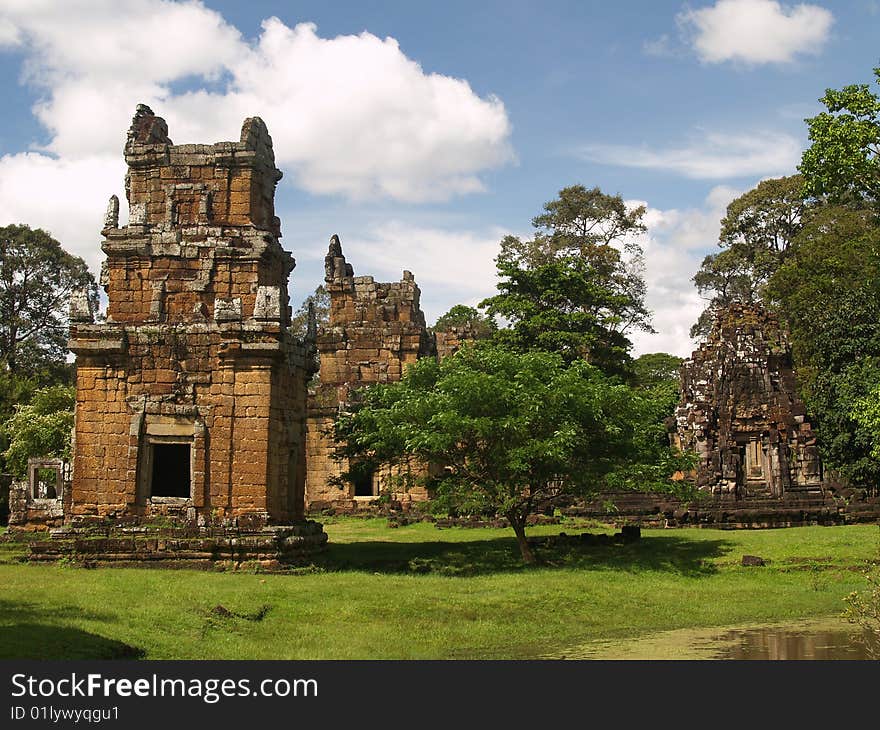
[[70, 106, 311, 526]]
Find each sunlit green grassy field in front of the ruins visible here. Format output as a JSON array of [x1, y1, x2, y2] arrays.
[[0, 518, 880, 659]]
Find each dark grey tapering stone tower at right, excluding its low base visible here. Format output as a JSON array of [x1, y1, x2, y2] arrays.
[[676, 303, 823, 497]]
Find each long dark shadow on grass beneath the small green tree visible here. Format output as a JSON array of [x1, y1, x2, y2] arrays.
[[317, 535, 733, 576]]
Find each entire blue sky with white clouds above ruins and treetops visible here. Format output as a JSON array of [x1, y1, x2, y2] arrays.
[[0, 0, 880, 355]]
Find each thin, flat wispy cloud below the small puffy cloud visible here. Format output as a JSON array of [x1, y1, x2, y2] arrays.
[[575, 131, 802, 180]]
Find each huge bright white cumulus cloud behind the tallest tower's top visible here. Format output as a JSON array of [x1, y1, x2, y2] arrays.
[[0, 0, 513, 268]]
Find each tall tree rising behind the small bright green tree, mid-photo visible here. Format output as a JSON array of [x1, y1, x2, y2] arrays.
[[481, 185, 653, 374]]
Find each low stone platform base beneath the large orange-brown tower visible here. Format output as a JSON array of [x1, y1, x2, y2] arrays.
[[16, 520, 327, 571]]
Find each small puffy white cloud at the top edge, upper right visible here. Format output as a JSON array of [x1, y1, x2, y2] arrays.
[[678, 0, 834, 64]]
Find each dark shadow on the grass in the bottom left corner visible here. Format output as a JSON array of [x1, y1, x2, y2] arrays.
[[0, 600, 144, 659]]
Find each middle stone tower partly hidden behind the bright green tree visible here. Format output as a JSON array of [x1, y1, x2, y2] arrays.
[[306, 236, 434, 509]]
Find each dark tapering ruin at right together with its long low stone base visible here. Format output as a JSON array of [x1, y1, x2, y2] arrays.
[[564, 303, 880, 527]]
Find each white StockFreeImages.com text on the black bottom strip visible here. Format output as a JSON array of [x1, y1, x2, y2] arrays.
[[12, 672, 318, 704]]
